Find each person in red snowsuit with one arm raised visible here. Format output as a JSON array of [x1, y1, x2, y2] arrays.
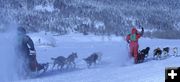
[[126, 27, 144, 63]]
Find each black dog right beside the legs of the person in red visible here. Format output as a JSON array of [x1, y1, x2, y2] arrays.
[[138, 47, 150, 63]]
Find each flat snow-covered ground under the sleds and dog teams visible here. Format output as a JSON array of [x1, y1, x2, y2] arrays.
[[7, 32, 180, 82]]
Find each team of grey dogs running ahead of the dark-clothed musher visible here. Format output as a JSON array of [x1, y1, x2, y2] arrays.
[[51, 52, 102, 70]]
